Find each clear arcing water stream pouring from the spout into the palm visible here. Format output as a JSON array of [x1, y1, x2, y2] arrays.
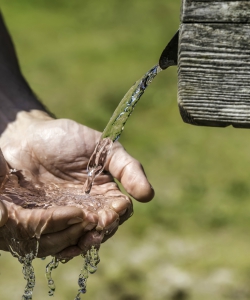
[[85, 65, 162, 194]]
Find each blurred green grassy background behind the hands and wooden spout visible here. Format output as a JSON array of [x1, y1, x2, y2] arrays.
[[0, 0, 250, 300]]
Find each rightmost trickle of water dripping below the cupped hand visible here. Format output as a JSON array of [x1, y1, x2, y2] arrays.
[[74, 246, 100, 300]]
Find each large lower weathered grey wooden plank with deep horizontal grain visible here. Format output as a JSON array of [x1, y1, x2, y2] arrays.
[[178, 24, 250, 128]]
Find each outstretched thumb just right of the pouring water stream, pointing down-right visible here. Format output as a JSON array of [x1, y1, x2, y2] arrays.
[[107, 143, 154, 202]]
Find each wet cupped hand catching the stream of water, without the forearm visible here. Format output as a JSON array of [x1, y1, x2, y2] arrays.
[[0, 111, 154, 257]]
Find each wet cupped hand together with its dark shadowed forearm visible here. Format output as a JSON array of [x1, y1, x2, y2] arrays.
[[0, 14, 154, 259]]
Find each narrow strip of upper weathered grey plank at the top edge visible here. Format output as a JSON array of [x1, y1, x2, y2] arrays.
[[181, 0, 250, 23]]
